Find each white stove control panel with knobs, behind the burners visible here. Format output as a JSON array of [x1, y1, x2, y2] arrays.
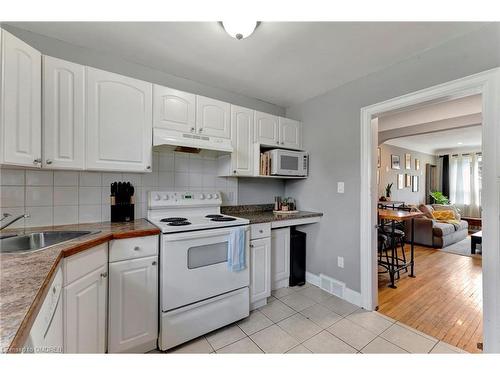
[[148, 191, 222, 209]]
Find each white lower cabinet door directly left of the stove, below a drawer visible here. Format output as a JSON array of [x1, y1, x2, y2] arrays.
[[108, 256, 158, 353]]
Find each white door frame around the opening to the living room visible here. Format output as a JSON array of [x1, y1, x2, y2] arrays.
[[360, 68, 500, 353]]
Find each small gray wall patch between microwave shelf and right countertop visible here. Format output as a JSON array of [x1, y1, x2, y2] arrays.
[[238, 177, 285, 204]]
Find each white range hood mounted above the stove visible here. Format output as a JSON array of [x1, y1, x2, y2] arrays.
[[153, 128, 233, 153]]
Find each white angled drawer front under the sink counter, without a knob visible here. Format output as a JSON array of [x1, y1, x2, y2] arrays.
[[63, 243, 108, 286]]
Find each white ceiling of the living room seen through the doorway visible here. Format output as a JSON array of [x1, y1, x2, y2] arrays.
[[385, 125, 481, 155]]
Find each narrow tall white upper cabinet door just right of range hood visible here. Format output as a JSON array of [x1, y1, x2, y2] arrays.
[[231, 105, 254, 176]]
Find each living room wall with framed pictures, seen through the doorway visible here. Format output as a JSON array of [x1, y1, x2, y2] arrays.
[[378, 144, 437, 204]]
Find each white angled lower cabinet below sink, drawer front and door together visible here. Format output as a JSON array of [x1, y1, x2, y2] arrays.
[[64, 244, 108, 353]]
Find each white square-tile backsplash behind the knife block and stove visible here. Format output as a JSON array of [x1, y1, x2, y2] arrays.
[[0, 151, 238, 228]]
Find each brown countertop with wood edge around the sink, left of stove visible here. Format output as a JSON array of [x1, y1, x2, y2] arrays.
[[0, 219, 160, 353]]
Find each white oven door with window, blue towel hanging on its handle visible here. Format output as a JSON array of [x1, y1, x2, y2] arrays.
[[160, 225, 250, 312]]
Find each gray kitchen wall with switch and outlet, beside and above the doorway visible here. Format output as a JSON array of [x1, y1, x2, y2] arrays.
[[286, 23, 500, 291]]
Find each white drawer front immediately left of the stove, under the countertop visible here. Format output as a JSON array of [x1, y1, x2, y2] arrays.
[[109, 236, 159, 262]]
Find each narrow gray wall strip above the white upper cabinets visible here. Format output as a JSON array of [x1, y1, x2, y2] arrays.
[[1, 23, 285, 116]]
